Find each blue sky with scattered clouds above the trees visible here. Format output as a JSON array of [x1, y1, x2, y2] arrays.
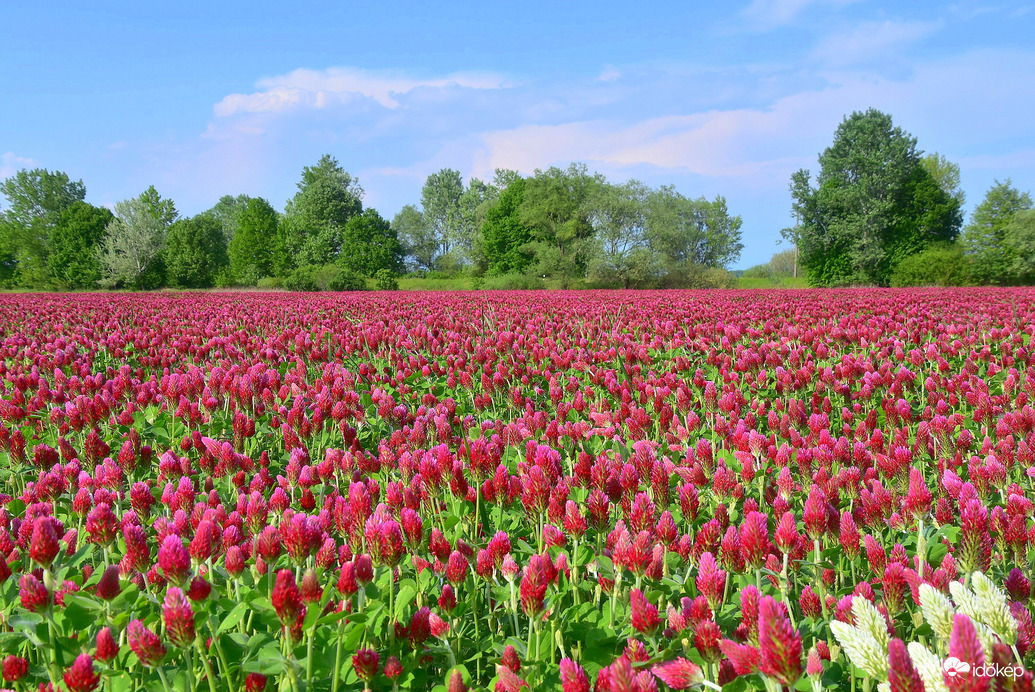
[[0, 0, 1035, 267]]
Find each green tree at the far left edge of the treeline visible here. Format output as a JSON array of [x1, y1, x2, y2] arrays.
[[0, 169, 86, 289]]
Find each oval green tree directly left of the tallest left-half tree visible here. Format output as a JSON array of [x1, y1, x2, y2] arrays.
[[228, 198, 286, 285]]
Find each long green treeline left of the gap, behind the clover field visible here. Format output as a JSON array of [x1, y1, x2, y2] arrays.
[[0, 155, 743, 291]]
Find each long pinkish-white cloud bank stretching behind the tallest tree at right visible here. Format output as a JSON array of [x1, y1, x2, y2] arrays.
[[473, 45, 1035, 189]]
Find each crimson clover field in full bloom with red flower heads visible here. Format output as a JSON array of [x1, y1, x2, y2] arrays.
[[0, 289, 1035, 692]]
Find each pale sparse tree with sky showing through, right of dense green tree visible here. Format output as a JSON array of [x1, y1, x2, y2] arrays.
[[589, 180, 661, 289]]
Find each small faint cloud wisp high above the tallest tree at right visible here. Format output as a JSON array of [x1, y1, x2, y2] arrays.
[[812, 20, 942, 66]]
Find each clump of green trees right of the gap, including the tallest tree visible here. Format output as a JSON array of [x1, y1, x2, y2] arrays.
[[778, 109, 1035, 287]]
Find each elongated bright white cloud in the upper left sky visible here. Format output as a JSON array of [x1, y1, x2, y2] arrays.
[[213, 67, 507, 117]]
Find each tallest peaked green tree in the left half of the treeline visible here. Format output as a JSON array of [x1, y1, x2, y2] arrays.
[[284, 154, 363, 266]]
